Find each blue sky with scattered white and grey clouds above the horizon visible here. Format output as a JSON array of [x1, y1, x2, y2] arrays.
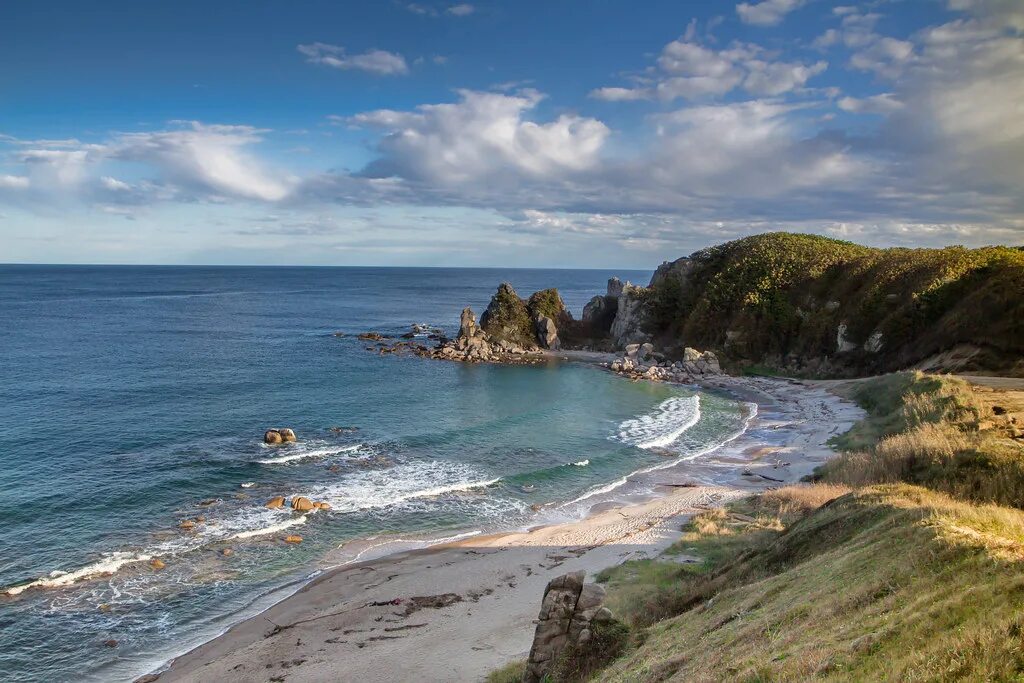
[[0, 0, 1024, 268]]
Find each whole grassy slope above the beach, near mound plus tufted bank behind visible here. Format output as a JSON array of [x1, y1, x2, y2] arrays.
[[573, 374, 1024, 681]]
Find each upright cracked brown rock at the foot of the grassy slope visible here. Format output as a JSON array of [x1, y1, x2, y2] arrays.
[[522, 571, 612, 683]]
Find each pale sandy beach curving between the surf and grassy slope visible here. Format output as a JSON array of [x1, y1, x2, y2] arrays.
[[147, 377, 861, 683]]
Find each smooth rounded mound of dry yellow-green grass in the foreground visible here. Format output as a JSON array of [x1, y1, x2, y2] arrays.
[[598, 484, 1024, 681]]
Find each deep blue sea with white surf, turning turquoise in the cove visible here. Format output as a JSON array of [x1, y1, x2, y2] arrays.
[[0, 266, 746, 681]]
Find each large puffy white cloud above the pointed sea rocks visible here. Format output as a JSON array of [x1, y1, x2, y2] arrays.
[[348, 90, 609, 184]]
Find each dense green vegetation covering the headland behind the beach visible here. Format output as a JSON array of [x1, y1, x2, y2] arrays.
[[649, 232, 1024, 375]]
